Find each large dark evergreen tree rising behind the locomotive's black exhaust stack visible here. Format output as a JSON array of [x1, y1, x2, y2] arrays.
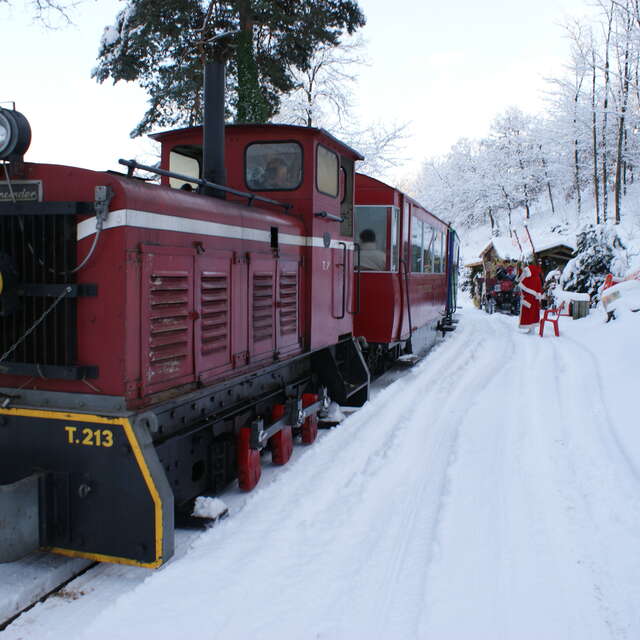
[[93, 0, 364, 136]]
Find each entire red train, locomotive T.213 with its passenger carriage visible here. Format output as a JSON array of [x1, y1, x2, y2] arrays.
[[0, 65, 457, 567]]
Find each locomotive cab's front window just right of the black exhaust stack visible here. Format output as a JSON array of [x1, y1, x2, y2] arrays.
[[245, 142, 302, 191]]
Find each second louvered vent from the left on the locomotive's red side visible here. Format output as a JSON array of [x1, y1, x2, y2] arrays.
[[201, 272, 229, 356]]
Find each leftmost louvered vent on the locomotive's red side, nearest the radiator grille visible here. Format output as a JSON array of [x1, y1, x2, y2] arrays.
[[149, 271, 190, 375]]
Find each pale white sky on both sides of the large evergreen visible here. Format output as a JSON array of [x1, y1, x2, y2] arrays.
[[0, 0, 589, 181]]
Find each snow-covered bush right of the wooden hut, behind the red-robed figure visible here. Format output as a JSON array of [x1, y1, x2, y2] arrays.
[[560, 224, 628, 302]]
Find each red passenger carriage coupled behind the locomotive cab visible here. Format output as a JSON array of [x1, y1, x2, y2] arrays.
[[354, 174, 459, 372]]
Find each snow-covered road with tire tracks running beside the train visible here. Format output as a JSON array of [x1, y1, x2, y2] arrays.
[[5, 309, 640, 640]]
